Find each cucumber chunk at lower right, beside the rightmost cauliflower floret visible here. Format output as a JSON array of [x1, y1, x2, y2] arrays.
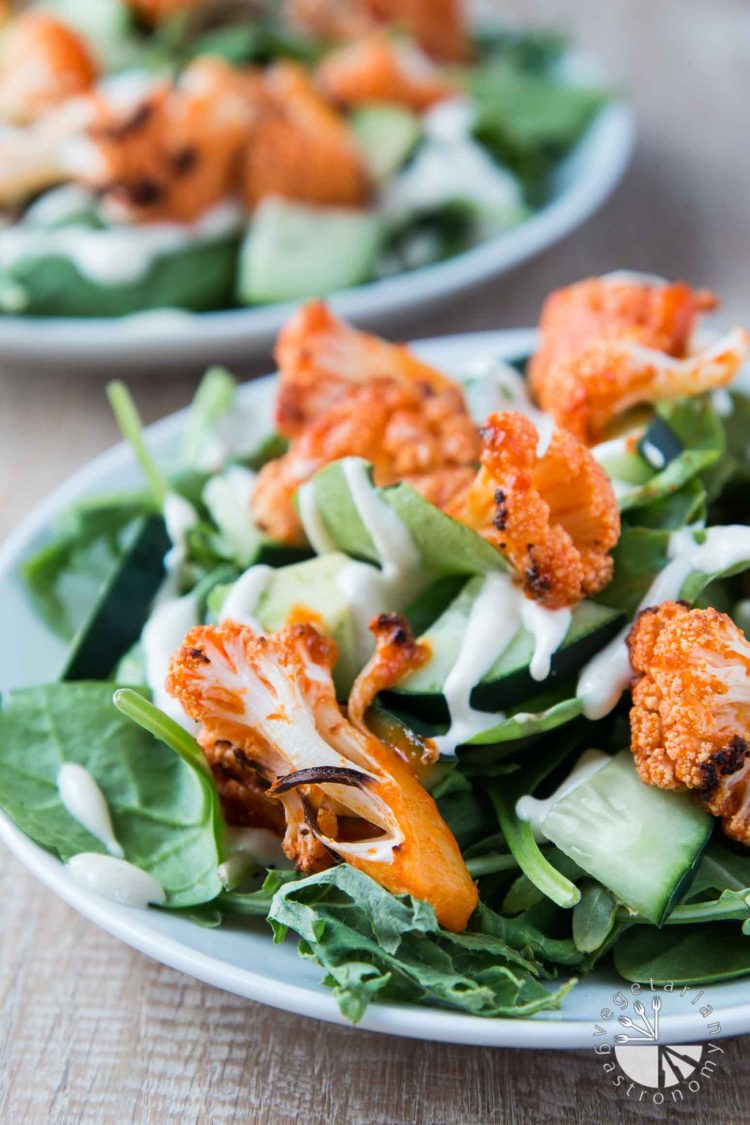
[[540, 750, 713, 926]]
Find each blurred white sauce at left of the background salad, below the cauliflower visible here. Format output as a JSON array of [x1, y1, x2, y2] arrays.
[[0, 203, 242, 286]]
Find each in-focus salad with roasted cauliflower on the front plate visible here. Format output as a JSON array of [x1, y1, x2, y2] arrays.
[[0, 273, 750, 1022]]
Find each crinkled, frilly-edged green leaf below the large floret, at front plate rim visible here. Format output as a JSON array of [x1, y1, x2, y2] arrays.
[[269, 864, 571, 1023]]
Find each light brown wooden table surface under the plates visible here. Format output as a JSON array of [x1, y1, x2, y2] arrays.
[[0, 0, 750, 1125]]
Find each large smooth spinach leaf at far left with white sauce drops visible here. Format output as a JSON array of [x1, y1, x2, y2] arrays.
[[0, 683, 222, 907]]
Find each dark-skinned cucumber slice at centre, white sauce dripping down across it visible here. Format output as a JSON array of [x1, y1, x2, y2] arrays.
[[388, 576, 623, 723]]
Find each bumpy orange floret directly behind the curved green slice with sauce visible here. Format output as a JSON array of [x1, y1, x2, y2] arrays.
[[252, 379, 479, 543]]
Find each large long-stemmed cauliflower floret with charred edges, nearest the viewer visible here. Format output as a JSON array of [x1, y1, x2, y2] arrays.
[[166, 622, 477, 930]]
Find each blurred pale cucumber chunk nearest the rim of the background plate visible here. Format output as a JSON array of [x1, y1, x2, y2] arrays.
[[238, 197, 380, 305]]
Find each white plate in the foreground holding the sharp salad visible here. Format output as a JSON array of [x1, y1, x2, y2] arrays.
[[0, 332, 750, 1047]]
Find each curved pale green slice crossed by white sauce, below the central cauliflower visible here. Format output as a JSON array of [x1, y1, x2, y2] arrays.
[[313, 461, 507, 578]]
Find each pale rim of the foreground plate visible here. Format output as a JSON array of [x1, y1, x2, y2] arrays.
[[0, 329, 750, 1050]]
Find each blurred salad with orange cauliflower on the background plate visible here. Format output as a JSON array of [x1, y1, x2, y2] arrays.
[[0, 0, 605, 317]]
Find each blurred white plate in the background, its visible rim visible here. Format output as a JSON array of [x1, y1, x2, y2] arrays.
[[0, 94, 634, 375]]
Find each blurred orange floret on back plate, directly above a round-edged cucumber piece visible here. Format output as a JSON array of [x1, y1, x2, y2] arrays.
[[317, 33, 457, 111]]
